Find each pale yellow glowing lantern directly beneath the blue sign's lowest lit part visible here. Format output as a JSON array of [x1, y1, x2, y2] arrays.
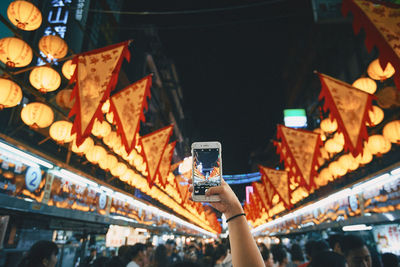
[[29, 66, 61, 93]]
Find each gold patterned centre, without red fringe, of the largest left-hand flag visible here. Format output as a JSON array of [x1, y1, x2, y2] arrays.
[[77, 45, 124, 135]]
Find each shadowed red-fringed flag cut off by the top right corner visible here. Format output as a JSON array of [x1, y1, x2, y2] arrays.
[[342, 0, 400, 90]]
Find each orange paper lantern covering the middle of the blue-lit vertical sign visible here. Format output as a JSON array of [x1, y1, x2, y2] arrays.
[[39, 35, 68, 59]]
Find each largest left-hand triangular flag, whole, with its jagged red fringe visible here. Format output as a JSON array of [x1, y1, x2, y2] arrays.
[[69, 41, 130, 146]]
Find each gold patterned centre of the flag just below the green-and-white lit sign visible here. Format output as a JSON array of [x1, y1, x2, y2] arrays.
[[279, 126, 319, 187]]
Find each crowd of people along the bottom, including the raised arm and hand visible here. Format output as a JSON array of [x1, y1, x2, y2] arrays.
[[15, 182, 399, 267]]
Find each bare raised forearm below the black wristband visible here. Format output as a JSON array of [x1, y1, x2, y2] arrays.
[[228, 216, 265, 267]]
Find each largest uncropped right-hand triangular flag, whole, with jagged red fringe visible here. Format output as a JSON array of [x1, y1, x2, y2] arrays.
[[318, 73, 374, 157]]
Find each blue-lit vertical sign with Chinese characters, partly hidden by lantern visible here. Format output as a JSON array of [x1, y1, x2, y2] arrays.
[[37, 0, 72, 65]]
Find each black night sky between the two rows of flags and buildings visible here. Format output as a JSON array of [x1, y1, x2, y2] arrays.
[[126, 0, 313, 174]]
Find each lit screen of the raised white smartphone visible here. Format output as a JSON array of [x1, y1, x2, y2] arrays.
[[193, 148, 221, 195]]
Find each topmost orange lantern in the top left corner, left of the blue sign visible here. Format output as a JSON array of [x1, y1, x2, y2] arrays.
[[7, 1, 42, 31]]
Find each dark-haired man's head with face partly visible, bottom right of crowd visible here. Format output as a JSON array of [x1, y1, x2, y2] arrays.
[[342, 235, 372, 267]]
